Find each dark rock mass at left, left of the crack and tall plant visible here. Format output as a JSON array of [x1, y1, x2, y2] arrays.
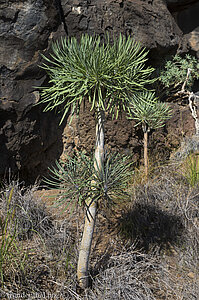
[[0, 0, 61, 180]]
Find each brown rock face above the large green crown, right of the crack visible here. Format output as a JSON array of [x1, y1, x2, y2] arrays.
[[63, 0, 182, 50]]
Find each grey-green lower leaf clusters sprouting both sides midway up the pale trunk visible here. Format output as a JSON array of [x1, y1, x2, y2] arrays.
[[45, 153, 132, 211]]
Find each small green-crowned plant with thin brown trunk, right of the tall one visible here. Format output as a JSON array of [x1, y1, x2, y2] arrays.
[[128, 91, 171, 178]]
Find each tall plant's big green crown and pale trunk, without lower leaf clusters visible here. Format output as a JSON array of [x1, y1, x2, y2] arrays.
[[37, 35, 153, 289]]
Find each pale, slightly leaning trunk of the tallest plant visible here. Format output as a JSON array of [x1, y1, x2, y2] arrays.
[[77, 111, 104, 289]]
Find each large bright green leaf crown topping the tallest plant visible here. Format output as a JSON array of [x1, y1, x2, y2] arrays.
[[40, 34, 154, 122]]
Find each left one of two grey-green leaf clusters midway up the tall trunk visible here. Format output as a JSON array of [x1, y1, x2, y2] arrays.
[[44, 153, 93, 211]]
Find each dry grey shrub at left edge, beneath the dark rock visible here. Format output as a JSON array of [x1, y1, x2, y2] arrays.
[[0, 181, 52, 240]]
